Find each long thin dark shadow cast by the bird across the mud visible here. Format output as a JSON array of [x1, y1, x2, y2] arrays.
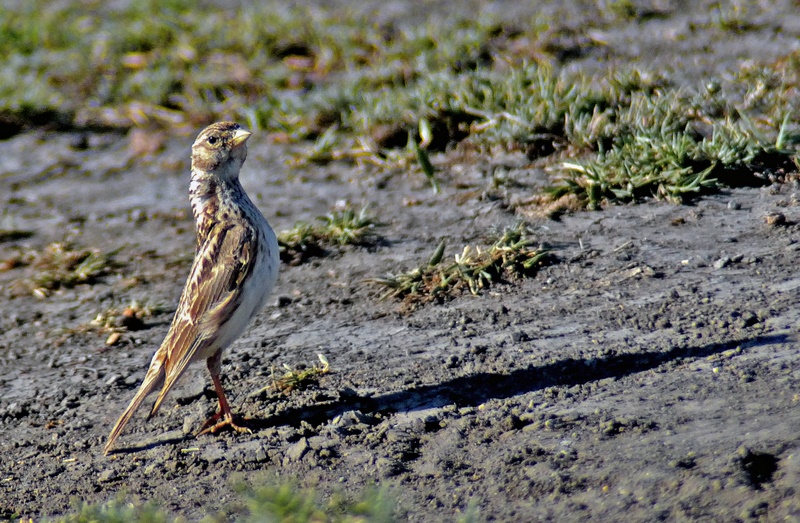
[[106, 334, 789, 453]]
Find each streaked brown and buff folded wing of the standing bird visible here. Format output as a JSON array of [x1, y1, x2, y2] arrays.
[[146, 224, 254, 415]]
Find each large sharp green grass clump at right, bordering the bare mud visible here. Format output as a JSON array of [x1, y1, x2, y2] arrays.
[[550, 97, 794, 208]]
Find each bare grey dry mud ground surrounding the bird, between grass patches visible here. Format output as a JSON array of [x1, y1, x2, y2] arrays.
[[0, 1, 800, 521]]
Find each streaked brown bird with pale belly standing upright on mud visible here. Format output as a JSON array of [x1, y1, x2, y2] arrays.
[[104, 122, 280, 455]]
